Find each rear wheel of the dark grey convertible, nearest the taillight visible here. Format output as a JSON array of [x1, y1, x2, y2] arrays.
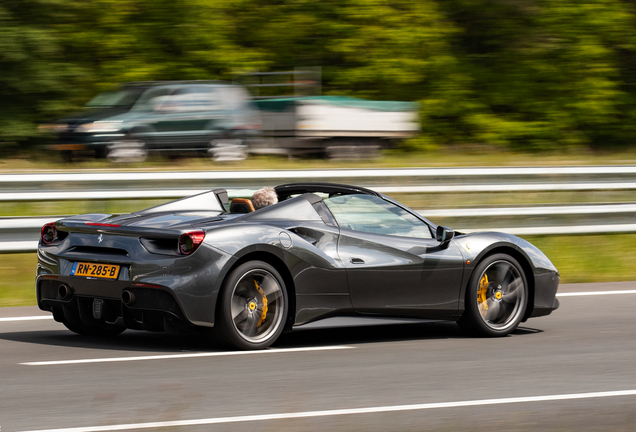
[[214, 261, 289, 350]]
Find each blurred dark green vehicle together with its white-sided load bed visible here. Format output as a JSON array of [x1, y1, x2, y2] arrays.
[[41, 77, 419, 162]]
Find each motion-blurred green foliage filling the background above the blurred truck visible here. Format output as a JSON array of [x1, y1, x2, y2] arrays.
[[0, 0, 636, 150]]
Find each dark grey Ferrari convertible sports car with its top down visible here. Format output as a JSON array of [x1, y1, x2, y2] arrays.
[[36, 183, 559, 349]]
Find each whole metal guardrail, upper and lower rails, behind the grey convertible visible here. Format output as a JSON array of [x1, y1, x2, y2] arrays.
[[0, 166, 636, 253]]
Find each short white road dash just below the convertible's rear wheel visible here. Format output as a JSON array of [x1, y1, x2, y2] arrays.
[[19, 345, 355, 366]]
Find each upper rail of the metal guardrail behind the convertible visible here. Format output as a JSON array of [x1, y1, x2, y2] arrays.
[[0, 165, 636, 202]]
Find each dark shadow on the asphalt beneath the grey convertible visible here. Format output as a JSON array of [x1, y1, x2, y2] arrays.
[[0, 322, 542, 353]]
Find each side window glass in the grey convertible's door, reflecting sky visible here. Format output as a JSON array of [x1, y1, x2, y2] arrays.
[[324, 195, 432, 239]]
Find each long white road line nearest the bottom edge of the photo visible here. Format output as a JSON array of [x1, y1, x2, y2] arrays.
[[17, 390, 636, 432]]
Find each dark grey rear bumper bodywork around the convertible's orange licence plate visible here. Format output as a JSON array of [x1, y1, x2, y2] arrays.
[[36, 241, 233, 328]]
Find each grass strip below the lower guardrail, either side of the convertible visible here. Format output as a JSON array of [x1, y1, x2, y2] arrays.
[[0, 234, 636, 306]]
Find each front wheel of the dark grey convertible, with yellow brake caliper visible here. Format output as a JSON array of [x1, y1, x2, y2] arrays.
[[458, 254, 528, 337]]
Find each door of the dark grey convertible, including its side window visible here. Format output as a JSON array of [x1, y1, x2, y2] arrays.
[[325, 195, 463, 317]]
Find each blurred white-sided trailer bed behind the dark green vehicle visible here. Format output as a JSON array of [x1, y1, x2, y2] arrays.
[[249, 96, 420, 159]]
